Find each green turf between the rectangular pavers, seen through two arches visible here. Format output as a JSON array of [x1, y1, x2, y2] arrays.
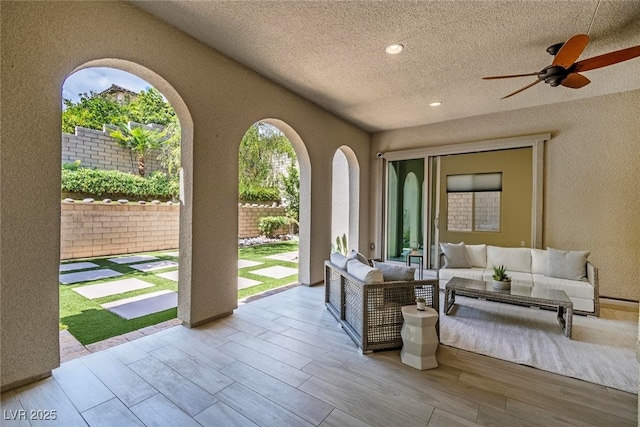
[[60, 241, 298, 345]]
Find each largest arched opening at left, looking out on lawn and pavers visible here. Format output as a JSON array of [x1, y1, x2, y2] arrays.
[[60, 59, 193, 354]]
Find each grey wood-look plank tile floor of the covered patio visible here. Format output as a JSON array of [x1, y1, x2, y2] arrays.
[[0, 286, 638, 427]]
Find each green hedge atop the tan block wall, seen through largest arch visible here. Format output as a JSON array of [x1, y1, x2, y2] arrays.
[[62, 165, 180, 200]]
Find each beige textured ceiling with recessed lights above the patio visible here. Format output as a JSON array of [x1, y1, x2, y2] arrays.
[[132, 0, 640, 131]]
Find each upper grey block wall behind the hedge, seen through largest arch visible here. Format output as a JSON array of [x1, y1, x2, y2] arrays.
[[62, 127, 164, 175]]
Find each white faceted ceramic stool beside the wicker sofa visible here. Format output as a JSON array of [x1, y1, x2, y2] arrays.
[[400, 304, 438, 370]]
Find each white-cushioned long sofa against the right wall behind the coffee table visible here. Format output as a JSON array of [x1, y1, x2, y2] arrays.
[[438, 243, 600, 316]]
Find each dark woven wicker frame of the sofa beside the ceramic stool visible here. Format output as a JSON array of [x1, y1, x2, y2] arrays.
[[324, 261, 440, 353]]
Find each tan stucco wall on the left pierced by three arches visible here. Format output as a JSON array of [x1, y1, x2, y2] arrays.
[[0, 1, 370, 388]]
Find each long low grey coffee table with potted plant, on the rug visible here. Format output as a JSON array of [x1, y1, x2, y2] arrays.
[[444, 277, 573, 338]]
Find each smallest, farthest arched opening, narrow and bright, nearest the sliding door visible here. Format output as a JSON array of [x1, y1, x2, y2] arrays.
[[331, 146, 363, 252]]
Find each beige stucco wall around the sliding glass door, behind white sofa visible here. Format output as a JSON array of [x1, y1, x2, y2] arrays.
[[371, 89, 640, 301]]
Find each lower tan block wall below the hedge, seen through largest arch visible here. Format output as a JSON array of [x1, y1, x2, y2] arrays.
[[60, 202, 180, 260]]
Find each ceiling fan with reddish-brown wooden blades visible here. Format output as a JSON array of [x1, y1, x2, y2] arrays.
[[483, 34, 640, 99]]
